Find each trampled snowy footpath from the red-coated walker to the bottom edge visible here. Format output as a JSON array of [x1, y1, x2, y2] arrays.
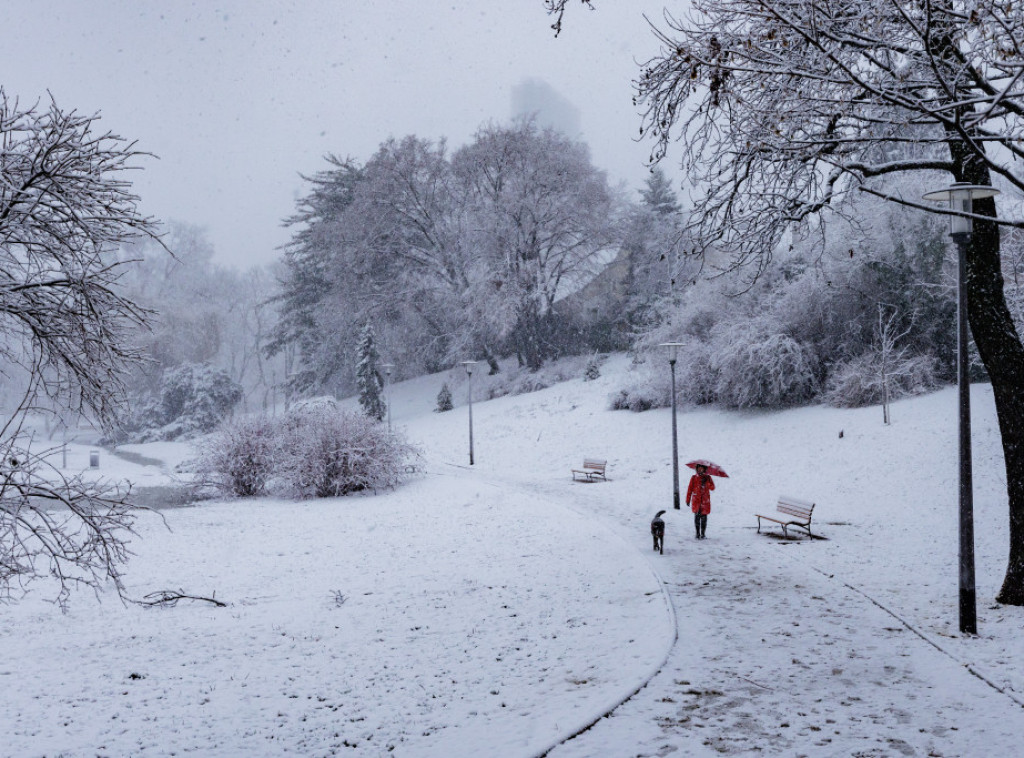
[[550, 532, 1024, 758]]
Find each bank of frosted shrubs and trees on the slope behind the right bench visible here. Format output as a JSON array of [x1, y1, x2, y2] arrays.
[[615, 189, 954, 413]]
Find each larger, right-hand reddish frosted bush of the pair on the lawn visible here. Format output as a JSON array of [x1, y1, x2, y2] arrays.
[[275, 409, 416, 498]]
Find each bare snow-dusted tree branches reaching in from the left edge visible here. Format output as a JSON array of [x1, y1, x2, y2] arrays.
[[0, 88, 155, 603]]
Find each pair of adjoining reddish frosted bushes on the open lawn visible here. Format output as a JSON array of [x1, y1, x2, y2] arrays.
[[197, 404, 417, 498]]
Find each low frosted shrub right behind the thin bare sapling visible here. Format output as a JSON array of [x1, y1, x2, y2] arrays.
[[824, 353, 939, 408]]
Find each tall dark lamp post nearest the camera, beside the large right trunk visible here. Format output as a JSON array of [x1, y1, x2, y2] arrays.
[[925, 181, 999, 634]]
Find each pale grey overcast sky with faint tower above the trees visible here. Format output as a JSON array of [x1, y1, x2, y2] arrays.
[[6, 0, 675, 266]]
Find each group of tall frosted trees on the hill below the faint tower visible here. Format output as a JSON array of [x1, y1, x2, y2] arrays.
[[270, 119, 655, 392]]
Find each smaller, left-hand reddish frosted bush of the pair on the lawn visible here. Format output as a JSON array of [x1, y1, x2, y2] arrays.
[[195, 416, 278, 498]]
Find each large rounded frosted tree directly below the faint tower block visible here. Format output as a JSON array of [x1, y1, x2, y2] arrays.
[[453, 119, 615, 370]]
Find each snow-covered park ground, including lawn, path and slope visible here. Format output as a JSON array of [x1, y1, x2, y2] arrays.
[[0, 356, 1024, 758]]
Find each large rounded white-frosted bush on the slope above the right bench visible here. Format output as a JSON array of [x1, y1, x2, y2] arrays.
[[711, 319, 817, 408]]
